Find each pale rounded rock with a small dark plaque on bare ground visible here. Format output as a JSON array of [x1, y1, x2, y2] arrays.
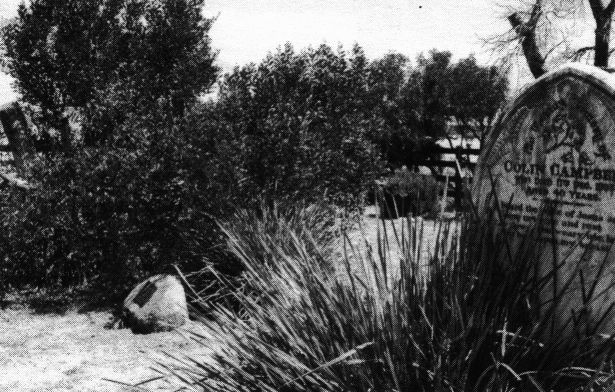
[[122, 275, 188, 333]]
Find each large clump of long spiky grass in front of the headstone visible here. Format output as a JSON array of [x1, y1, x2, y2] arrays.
[[162, 204, 615, 391]]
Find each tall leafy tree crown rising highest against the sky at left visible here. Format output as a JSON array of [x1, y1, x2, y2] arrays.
[[4, 0, 217, 151]]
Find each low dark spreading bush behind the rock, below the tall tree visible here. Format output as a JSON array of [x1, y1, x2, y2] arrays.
[[0, 115, 238, 294]]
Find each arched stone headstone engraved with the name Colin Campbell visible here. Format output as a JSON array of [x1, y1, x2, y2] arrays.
[[473, 64, 615, 333]]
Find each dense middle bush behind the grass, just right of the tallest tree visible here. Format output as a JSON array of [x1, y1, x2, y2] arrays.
[[207, 45, 382, 209]]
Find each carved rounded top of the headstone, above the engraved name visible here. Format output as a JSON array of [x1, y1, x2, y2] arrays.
[[472, 63, 615, 211]]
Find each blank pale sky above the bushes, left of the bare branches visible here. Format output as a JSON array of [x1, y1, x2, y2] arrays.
[[0, 0, 528, 103]]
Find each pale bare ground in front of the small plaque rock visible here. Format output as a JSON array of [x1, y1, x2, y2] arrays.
[[0, 308, 214, 392]]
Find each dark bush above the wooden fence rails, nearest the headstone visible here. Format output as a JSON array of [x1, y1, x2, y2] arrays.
[[366, 50, 508, 169]]
